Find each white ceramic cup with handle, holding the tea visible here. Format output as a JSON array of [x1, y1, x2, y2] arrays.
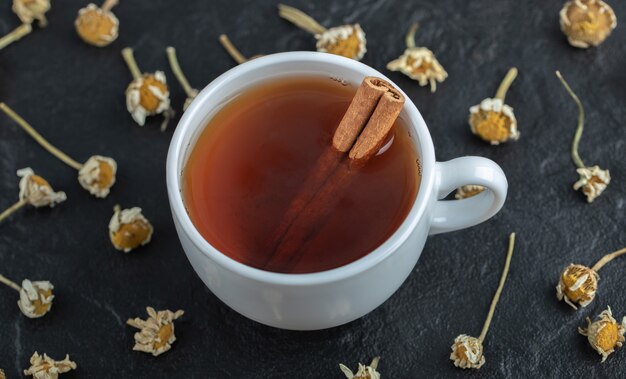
[[167, 52, 508, 330]]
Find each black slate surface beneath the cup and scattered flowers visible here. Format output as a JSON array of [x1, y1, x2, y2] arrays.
[[0, 0, 626, 379]]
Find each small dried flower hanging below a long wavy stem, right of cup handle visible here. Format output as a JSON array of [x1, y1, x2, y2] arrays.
[[556, 71, 611, 203]]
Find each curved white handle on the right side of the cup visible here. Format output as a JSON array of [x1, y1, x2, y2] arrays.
[[430, 157, 508, 235]]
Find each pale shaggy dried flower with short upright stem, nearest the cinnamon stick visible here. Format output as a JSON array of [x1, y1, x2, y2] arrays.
[[387, 23, 448, 92]]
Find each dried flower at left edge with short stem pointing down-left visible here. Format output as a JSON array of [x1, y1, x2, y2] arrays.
[[0, 167, 67, 221]]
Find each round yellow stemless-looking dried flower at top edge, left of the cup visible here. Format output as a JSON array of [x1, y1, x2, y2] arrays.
[[74, 0, 120, 47]]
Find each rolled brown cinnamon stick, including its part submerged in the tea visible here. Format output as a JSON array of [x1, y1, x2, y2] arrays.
[[265, 77, 404, 270]]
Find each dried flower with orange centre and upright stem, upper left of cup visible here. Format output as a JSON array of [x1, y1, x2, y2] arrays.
[[122, 47, 174, 131]]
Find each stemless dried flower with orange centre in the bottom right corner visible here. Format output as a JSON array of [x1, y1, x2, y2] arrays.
[[578, 307, 626, 362]]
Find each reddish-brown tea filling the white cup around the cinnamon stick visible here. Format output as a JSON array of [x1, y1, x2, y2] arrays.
[[183, 77, 420, 273]]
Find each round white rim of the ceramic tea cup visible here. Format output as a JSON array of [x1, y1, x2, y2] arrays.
[[166, 51, 435, 286]]
